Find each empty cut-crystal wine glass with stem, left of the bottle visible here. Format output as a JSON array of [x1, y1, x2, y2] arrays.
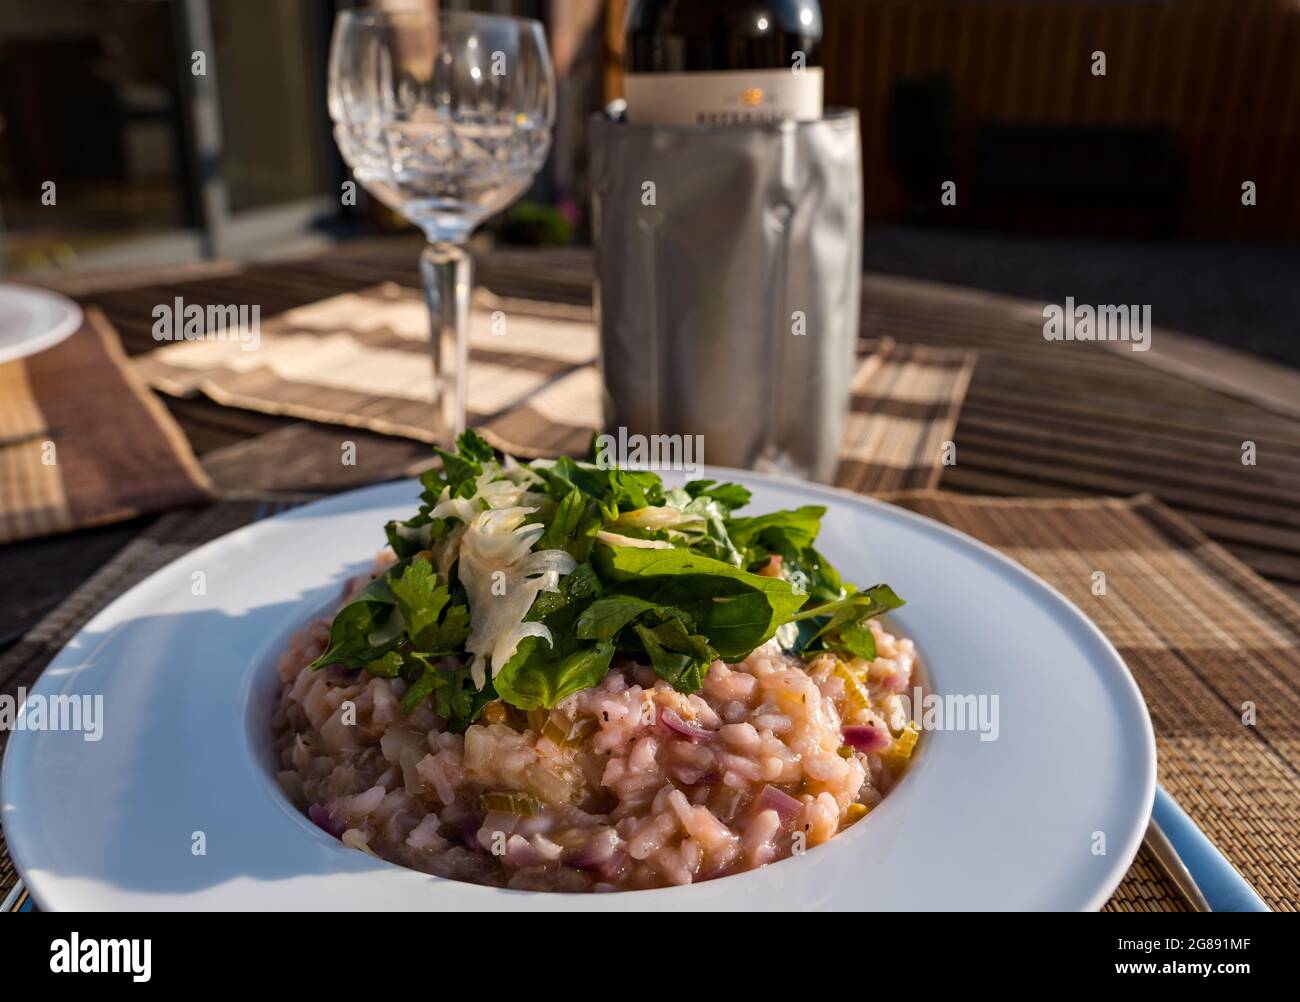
[[329, 10, 555, 443]]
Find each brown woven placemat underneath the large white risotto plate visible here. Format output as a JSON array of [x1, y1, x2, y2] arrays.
[[0, 491, 1300, 911]]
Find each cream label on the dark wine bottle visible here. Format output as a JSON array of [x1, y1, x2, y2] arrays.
[[624, 66, 823, 125]]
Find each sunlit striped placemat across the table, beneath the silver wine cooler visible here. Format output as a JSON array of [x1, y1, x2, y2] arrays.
[[135, 283, 975, 491]]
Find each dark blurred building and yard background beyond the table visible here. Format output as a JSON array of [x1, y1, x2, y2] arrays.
[[0, 0, 1300, 366]]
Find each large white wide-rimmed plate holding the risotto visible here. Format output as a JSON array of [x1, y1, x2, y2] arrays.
[[0, 470, 1156, 911]]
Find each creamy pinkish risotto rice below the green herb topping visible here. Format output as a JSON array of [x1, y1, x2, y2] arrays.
[[273, 620, 915, 892]]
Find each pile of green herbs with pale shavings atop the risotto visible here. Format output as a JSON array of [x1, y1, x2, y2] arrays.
[[311, 431, 902, 730]]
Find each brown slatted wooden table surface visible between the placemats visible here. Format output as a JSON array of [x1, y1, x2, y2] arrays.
[[0, 240, 1300, 909]]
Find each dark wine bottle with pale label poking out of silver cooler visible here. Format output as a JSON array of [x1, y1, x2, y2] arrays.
[[624, 0, 822, 125]]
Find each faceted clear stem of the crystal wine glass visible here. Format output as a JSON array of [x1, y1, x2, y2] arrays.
[[420, 242, 471, 446]]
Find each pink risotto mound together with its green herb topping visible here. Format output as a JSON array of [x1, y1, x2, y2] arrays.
[[272, 431, 918, 892]]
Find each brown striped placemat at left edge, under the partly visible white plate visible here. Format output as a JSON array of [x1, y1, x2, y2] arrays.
[[0, 309, 208, 543]]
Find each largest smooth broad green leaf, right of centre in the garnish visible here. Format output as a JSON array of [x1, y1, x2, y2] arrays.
[[592, 543, 806, 662]]
